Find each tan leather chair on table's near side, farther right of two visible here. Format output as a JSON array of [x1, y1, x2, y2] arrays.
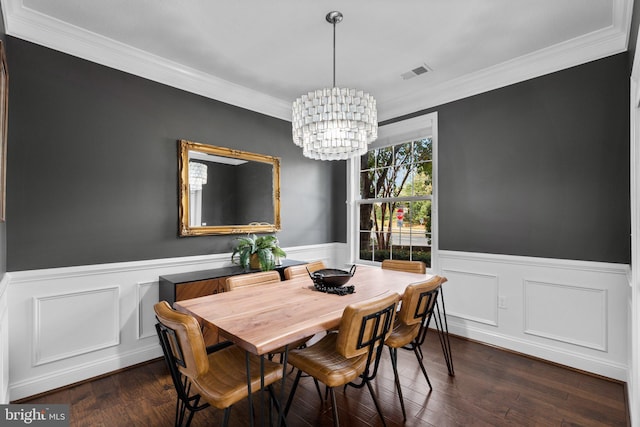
[[385, 276, 446, 421]]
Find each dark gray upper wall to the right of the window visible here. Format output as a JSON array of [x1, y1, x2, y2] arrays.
[[389, 53, 630, 263]]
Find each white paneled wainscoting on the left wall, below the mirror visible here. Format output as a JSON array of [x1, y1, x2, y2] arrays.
[[7, 244, 338, 403]]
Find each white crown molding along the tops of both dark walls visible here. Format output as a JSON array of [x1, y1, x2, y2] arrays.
[[2, 0, 633, 121]]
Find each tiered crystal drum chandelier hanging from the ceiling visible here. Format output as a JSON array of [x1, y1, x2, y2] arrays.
[[291, 11, 378, 160]]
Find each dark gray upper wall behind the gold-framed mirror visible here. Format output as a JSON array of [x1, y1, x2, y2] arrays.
[[6, 37, 346, 271]]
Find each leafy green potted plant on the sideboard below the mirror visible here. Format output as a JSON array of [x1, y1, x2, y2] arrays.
[[231, 234, 287, 271]]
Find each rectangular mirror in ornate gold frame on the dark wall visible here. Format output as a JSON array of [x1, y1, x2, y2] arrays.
[[178, 139, 280, 236]]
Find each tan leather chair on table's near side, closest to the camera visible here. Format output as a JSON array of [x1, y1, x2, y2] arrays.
[[285, 293, 399, 426]]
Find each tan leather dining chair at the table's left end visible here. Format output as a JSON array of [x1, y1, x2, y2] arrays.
[[154, 301, 283, 426]]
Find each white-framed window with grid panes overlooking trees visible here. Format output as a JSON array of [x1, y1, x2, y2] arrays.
[[345, 111, 439, 272]]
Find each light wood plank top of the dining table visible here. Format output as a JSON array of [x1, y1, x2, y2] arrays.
[[174, 265, 431, 355]]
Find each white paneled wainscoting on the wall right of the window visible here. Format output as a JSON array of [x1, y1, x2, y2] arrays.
[[439, 251, 629, 381]]
